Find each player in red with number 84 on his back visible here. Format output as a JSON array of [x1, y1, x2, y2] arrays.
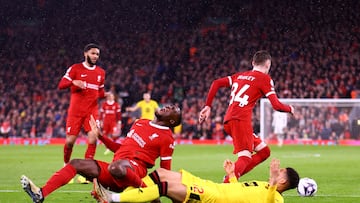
[[199, 50, 294, 182]]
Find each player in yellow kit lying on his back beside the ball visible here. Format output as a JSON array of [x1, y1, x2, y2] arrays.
[[92, 159, 299, 203]]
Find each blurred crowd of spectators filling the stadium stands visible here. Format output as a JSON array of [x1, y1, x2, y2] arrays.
[[0, 0, 360, 139]]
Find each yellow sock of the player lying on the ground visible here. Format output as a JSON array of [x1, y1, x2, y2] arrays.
[[120, 184, 160, 202]]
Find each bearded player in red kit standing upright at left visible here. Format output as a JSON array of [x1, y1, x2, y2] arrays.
[[58, 44, 105, 164]]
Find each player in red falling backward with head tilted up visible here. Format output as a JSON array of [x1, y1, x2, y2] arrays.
[[21, 105, 181, 202]]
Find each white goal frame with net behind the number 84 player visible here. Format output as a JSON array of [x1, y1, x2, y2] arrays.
[[260, 98, 360, 141]]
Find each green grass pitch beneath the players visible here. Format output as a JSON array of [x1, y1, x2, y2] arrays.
[[0, 145, 360, 203]]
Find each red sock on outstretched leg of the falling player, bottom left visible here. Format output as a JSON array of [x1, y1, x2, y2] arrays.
[[41, 164, 76, 197]]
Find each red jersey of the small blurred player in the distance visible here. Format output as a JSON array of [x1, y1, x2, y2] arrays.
[[100, 101, 121, 122]]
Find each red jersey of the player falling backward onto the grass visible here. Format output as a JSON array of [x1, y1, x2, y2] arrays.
[[113, 119, 175, 168]]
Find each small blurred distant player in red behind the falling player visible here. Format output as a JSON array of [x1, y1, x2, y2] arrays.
[[100, 92, 121, 152]]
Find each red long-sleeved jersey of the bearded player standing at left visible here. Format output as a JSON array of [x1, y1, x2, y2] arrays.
[[58, 63, 105, 117]]
